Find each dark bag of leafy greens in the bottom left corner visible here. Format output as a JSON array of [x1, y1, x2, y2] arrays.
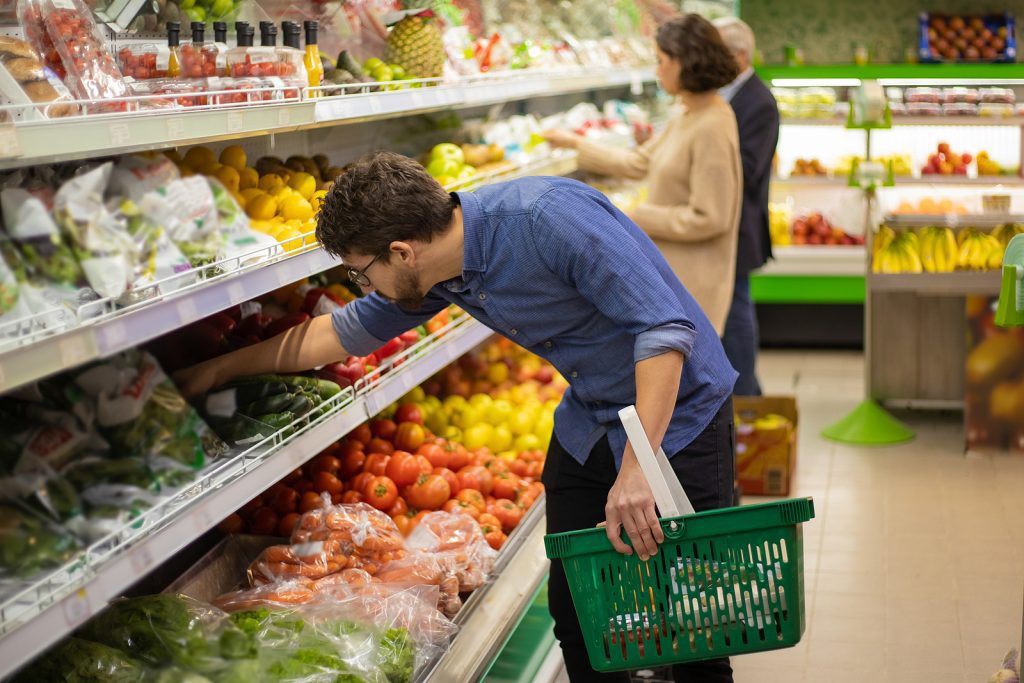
[[13, 638, 149, 683]]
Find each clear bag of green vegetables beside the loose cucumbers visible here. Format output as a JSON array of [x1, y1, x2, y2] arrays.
[[74, 350, 227, 469]]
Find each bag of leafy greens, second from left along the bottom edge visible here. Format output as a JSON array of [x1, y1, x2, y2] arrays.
[[79, 594, 259, 674]]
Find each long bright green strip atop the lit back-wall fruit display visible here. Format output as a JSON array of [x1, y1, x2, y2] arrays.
[[757, 63, 1024, 81]]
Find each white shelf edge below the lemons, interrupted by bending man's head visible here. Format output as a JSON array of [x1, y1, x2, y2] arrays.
[[0, 151, 577, 392]]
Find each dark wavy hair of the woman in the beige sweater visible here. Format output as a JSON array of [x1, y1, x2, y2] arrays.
[[654, 14, 739, 92]]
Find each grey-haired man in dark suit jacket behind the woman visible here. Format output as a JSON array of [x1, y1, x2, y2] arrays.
[[715, 16, 778, 396]]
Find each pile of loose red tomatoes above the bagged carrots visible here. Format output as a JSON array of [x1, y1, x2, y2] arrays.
[[221, 403, 544, 549]]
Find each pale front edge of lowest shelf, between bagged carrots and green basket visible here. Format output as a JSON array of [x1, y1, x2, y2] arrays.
[[419, 499, 549, 683]]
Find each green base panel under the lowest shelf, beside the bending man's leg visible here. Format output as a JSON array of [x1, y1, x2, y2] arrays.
[[480, 580, 557, 683]]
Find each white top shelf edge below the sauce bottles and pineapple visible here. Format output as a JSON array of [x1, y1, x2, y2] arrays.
[[0, 67, 654, 169]]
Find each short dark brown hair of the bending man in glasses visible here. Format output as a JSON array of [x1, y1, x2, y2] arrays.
[[316, 152, 455, 262]]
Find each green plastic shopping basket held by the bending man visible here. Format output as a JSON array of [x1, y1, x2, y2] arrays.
[[544, 498, 814, 672]]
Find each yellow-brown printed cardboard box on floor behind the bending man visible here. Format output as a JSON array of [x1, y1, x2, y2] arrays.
[[733, 396, 798, 496]]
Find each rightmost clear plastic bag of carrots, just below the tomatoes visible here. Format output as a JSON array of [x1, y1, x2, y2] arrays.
[[406, 512, 498, 592]]
